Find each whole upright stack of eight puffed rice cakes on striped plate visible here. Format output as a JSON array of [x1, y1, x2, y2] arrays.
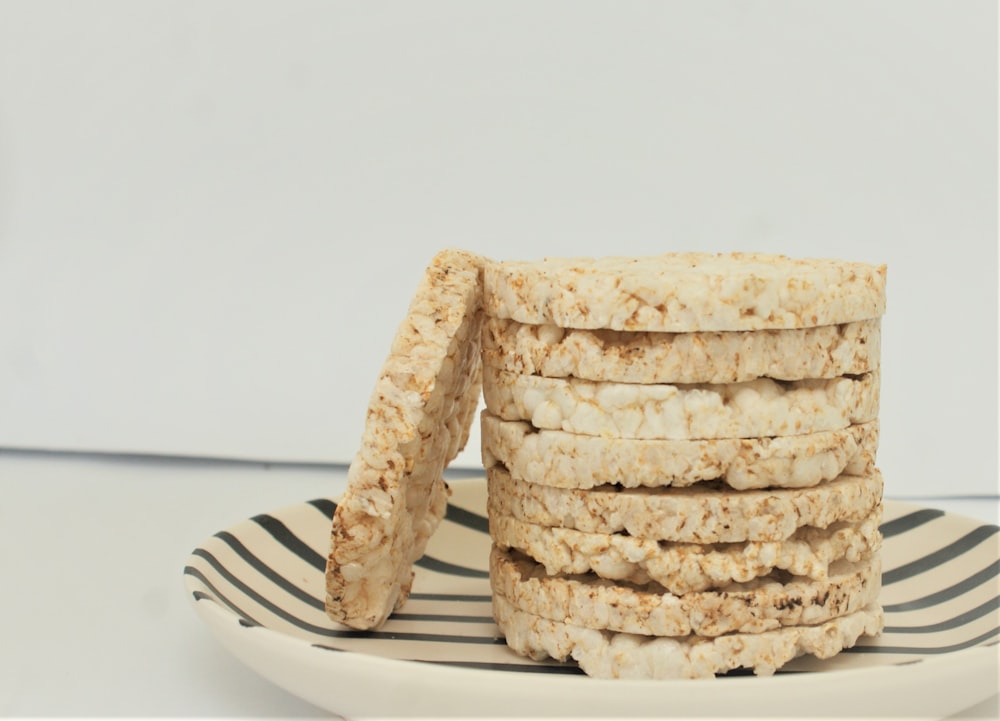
[[481, 254, 885, 678]]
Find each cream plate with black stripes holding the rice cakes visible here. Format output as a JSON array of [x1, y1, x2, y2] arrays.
[[184, 479, 1000, 718]]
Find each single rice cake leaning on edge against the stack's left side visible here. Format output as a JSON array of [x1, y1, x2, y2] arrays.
[[325, 250, 482, 629]]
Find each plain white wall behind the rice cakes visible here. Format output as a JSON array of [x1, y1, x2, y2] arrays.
[[0, 0, 997, 495]]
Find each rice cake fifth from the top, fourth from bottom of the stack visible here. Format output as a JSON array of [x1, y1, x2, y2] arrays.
[[486, 465, 883, 543]]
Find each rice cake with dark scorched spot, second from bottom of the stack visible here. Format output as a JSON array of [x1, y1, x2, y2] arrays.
[[490, 546, 882, 637]]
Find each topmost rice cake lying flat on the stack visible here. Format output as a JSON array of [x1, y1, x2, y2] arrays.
[[483, 253, 886, 333]]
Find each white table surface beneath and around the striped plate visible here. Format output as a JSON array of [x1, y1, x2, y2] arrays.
[[0, 451, 1000, 718]]
